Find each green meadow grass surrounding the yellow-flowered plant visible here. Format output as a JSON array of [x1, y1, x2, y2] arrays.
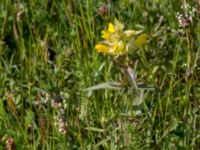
[[0, 0, 200, 150]]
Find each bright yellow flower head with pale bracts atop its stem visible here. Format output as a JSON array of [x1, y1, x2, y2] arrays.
[[95, 20, 148, 57]]
